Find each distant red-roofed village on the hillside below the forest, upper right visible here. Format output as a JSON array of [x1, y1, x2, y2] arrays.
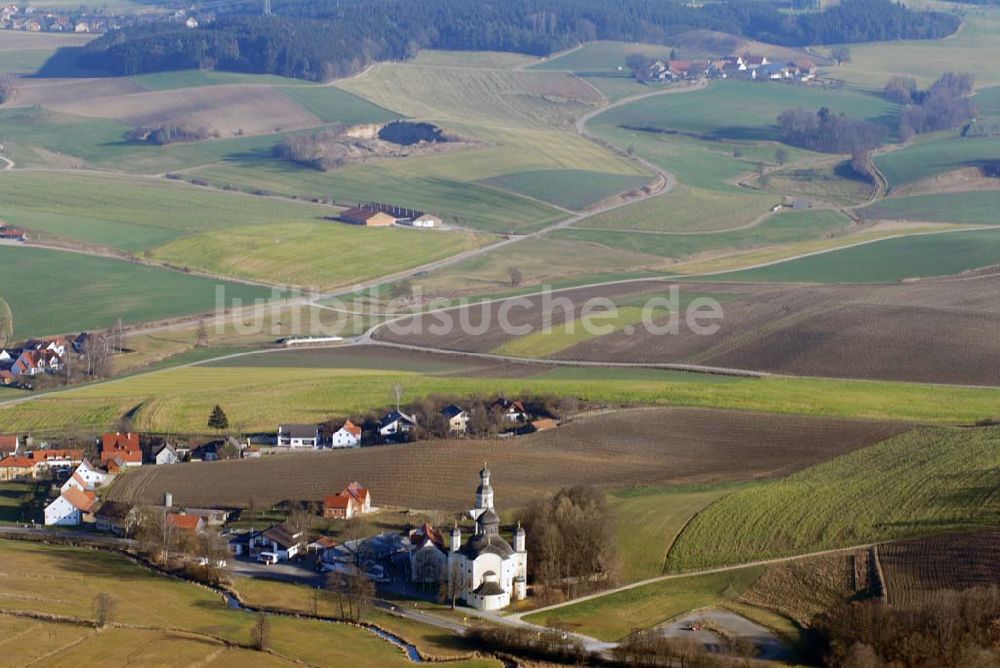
[[629, 54, 816, 83]]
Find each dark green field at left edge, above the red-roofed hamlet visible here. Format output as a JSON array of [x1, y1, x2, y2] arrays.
[[0, 246, 271, 338]]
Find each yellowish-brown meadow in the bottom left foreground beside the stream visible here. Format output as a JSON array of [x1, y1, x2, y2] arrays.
[[0, 541, 489, 666]]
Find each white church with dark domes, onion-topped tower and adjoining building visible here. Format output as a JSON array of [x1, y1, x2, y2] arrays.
[[410, 466, 528, 610]]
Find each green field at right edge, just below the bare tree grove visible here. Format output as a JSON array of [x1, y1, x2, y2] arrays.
[[875, 133, 1000, 188]]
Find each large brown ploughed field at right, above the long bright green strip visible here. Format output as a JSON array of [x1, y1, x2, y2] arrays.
[[374, 272, 1000, 386]]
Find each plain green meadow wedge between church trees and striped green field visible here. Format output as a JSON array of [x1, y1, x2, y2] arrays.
[[608, 484, 741, 582]]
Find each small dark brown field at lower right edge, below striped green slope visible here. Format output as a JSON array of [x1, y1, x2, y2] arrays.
[[878, 528, 1000, 606]]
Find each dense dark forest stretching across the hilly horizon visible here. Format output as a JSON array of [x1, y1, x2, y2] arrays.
[[81, 0, 960, 80]]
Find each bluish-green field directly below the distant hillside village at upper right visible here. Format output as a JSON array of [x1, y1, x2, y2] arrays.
[[595, 81, 899, 141]]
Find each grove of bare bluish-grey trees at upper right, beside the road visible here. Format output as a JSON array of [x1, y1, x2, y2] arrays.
[[885, 72, 976, 141]]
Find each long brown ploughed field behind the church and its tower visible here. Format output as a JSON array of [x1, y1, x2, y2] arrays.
[[103, 404, 903, 508]]
